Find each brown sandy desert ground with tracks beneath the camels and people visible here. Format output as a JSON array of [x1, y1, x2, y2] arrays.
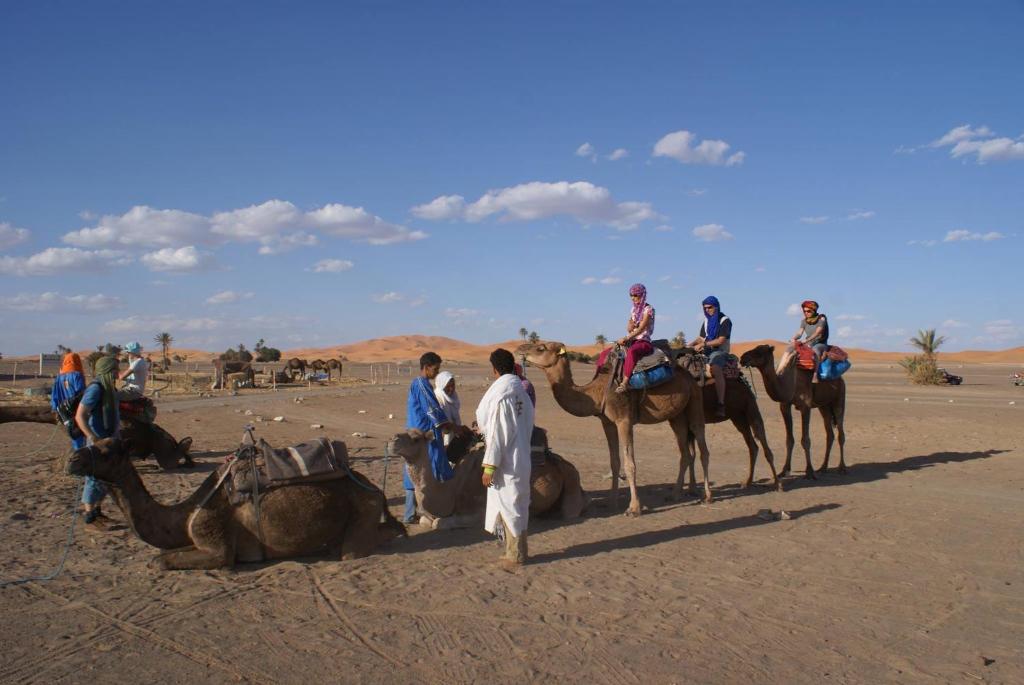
[[0, 365, 1024, 683]]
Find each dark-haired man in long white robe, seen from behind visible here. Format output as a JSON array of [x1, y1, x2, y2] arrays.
[[476, 349, 534, 568]]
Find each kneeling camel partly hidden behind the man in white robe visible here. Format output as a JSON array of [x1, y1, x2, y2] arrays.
[[388, 428, 587, 527]]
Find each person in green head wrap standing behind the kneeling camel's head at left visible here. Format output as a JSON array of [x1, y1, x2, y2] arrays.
[[75, 355, 121, 530]]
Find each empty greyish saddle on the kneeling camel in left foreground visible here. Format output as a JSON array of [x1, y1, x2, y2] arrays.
[[223, 437, 349, 504]]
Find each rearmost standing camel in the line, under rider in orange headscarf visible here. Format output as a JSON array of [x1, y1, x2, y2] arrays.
[[739, 345, 846, 479]]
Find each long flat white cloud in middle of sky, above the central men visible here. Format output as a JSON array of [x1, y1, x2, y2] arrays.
[[413, 181, 662, 230]]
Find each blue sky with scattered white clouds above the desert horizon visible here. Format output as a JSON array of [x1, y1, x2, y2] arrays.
[[0, 0, 1024, 354]]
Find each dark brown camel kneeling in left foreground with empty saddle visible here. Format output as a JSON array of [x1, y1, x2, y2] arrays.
[[68, 439, 406, 570]]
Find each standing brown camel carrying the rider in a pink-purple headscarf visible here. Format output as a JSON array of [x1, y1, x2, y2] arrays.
[[516, 342, 712, 516]]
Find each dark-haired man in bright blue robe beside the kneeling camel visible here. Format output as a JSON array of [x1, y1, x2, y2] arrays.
[[402, 352, 455, 523]]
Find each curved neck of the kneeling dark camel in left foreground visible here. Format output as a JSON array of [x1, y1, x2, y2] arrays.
[[112, 458, 217, 550]]
